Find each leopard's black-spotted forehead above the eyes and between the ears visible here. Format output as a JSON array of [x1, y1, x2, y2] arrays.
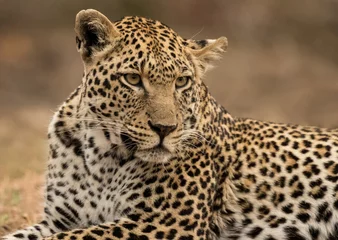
[[97, 16, 193, 83]]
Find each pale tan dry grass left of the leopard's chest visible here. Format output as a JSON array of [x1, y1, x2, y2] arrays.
[[0, 107, 52, 236]]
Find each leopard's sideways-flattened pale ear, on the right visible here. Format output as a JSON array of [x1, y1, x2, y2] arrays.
[[185, 37, 228, 73]]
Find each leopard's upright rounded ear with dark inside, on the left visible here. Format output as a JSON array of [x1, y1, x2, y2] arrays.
[[75, 9, 120, 63]]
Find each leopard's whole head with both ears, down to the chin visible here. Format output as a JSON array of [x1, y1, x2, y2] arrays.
[[76, 10, 225, 161]]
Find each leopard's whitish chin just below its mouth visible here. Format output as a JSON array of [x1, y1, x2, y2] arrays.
[[134, 147, 173, 163]]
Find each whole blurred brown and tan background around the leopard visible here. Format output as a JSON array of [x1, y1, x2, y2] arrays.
[[0, 0, 338, 235]]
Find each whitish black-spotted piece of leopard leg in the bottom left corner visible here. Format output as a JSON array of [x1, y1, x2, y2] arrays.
[[0, 221, 55, 240]]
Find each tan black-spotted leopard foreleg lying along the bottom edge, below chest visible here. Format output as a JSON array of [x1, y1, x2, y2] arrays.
[[43, 219, 194, 240]]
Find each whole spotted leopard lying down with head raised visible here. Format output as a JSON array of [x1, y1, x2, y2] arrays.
[[2, 9, 338, 240]]
